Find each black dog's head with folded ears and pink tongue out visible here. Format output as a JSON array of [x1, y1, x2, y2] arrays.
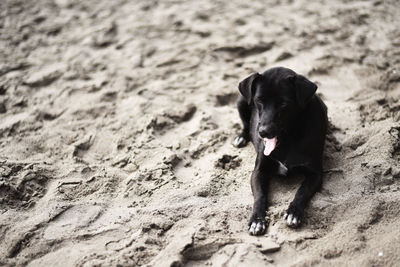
[[239, 67, 317, 154]]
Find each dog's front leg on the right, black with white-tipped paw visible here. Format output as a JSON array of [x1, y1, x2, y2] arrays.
[[284, 174, 322, 227]]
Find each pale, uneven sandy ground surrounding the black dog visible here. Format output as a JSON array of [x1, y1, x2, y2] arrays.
[[0, 0, 400, 266]]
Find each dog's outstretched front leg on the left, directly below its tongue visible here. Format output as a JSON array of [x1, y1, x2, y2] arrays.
[[249, 152, 279, 235]]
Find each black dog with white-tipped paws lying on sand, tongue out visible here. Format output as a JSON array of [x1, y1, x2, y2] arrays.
[[234, 67, 328, 235]]
